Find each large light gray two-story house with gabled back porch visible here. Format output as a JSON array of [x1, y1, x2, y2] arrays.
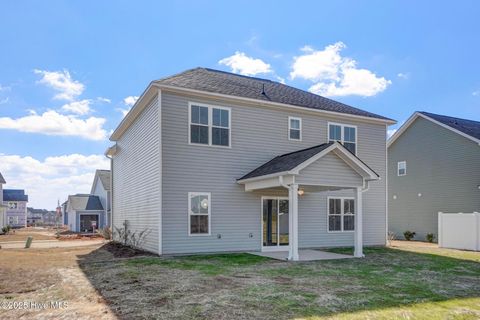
[[106, 68, 395, 260]]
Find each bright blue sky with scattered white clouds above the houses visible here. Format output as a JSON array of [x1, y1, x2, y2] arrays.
[[0, 0, 480, 209]]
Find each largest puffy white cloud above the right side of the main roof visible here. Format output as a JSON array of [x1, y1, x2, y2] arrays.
[[290, 42, 392, 97]]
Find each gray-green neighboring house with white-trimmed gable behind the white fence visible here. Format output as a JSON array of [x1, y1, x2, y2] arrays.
[[388, 112, 480, 239]]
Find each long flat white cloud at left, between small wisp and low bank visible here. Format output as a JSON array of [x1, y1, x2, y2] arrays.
[[0, 110, 106, 140]]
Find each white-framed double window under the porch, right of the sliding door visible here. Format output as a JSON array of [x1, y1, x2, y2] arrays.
[[328, 197, 355, 232]]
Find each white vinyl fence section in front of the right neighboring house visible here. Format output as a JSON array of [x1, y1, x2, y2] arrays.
[[438, 212, 480, 251]]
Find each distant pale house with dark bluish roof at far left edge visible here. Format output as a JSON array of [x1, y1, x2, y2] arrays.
[[3, 189, 28, 228]]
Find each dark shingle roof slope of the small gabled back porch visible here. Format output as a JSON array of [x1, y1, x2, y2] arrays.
[[238, 142, 333, 180]]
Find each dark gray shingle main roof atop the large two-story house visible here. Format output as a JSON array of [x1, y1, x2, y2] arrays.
[[155, 68, 393, 121]]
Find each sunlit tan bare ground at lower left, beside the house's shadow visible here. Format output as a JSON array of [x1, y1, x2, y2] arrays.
[[0, 245, 115, 319]]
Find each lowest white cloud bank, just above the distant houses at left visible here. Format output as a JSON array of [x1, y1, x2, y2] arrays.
[[0, 154, 109, 209]]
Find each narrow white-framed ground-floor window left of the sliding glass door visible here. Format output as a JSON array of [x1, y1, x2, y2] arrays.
[[188, 192, 210, 235]]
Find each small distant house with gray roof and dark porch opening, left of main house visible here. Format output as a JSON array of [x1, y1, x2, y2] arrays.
[[66, 194, 105, 233]]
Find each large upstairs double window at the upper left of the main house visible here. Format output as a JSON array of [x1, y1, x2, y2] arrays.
[[190, 104, 230, 147]]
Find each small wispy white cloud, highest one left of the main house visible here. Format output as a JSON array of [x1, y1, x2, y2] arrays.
[[34, 69, 85, 101]]
